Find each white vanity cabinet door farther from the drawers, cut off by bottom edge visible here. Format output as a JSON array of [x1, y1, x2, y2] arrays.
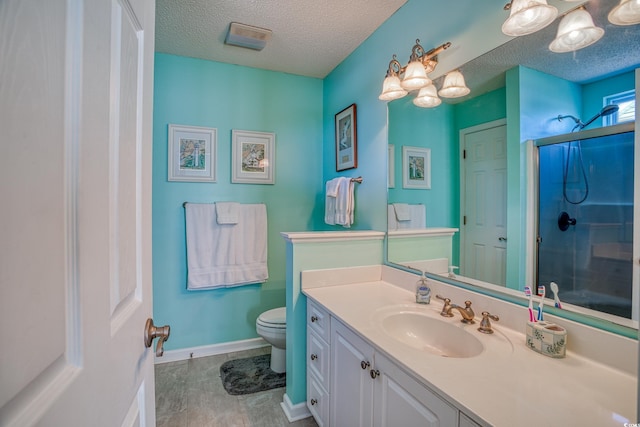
[[373, 354, 458, 427]]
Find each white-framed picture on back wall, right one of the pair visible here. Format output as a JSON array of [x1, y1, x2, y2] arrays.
[[231, 130, 276, 184]]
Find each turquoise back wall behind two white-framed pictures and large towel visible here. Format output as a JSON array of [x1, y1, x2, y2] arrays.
[[153, 54, 323, 350]]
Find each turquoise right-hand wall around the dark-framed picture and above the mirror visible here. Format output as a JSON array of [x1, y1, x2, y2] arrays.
[[323, 0, 520, 234]]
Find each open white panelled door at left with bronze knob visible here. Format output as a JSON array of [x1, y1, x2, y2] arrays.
[[0, 0, 155, 427]]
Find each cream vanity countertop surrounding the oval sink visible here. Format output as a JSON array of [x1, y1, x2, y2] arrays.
[[303, 281, 638, 427]]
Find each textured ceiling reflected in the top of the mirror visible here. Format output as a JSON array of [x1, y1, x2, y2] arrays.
[[450, 0, 640, 103]]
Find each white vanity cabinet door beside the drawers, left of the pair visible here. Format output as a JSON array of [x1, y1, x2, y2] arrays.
[[329, 321, 374, 427]]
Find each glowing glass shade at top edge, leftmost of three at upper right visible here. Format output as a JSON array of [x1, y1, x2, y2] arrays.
[[502, 0, 558, 36]]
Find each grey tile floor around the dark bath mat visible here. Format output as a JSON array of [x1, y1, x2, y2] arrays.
[[155, 347, 318, 427]]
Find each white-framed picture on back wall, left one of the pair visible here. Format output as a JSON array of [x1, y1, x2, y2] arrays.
[[168, 124, 217, 182]]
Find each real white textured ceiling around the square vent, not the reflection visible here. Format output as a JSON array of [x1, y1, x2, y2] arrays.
[[155, 0, 407, 78]]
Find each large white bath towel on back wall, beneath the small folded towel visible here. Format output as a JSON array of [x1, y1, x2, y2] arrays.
[[185, 203, 269, 290]]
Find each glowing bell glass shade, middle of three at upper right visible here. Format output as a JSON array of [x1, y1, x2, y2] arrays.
[[549, 8, 604, 53]]
